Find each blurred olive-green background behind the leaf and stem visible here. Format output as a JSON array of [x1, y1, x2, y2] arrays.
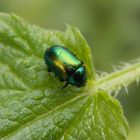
[[0, 0, 140, 140]]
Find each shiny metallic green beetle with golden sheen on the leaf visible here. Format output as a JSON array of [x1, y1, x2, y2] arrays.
[[44, 45, 87, 88]]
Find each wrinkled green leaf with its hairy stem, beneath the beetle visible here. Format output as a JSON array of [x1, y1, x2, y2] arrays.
[[0, 13, 140, 140]]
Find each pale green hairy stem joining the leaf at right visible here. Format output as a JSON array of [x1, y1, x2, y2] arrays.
[[94, 59, 140, 92]]
